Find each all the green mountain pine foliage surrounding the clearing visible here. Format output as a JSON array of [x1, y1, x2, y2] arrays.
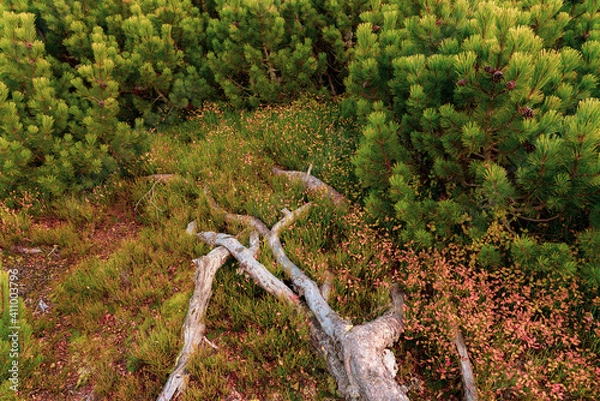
[[0, 0, 600, 283]]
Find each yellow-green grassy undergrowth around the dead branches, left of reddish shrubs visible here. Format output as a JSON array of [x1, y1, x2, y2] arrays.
[[8, 99, 380, 400]]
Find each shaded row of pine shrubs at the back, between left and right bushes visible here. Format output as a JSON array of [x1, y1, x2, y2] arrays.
[[27, 0, 367, 112]]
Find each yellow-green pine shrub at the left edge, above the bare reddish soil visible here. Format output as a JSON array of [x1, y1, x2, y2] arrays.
[[0, 12, 142, 201]]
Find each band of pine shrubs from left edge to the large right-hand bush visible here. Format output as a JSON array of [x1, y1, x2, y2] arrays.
[[0, 0, 366, 199]]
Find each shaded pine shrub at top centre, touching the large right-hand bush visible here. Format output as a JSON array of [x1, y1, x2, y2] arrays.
[[206, 0, 376, 106]]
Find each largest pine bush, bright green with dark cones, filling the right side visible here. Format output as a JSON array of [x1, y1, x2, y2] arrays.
[[347, 1, 600, 285]]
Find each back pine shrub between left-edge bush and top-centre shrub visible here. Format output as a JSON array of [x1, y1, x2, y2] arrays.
[[30, 0, 215, 124]]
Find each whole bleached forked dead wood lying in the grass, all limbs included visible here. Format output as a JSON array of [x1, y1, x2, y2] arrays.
[[158, 169, 476, 401]]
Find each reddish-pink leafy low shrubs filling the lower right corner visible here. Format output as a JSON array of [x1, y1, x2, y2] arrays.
[[396, 248, 600, 400]]
